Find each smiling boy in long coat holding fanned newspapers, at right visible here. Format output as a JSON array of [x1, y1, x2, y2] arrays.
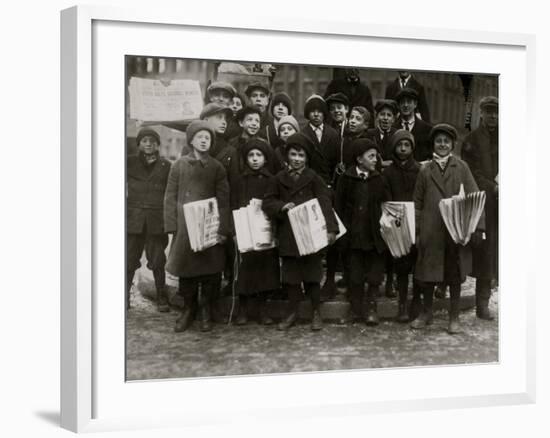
[[411, 123, 485, 334]]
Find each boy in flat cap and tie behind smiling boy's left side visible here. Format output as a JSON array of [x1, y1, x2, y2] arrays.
[[395, 87, 432, 162]]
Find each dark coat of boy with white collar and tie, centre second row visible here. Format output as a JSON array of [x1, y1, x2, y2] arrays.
[[300, 122, 340, 186]]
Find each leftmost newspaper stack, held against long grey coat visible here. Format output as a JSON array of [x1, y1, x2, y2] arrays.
[[183, 198, 220, 252]]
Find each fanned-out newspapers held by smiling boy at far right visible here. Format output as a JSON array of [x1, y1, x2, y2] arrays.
[[439, 184, 485, 245]]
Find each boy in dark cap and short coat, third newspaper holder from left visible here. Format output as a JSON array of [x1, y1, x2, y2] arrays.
[[262, 133, 338, 330]]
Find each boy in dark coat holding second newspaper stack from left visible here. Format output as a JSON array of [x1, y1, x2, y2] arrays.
[[231, 138, 280, 325]]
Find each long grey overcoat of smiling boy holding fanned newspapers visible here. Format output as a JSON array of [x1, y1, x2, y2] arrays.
[[413, 156, 485, 283]]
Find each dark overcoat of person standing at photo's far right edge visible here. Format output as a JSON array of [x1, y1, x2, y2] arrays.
[[462, 125, 498, 280]]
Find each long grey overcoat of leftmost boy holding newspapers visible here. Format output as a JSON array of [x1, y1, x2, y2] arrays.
[[164, 154, 230, 277]]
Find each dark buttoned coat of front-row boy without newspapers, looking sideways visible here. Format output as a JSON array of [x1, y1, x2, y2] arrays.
[[335, 166, 390, 254]]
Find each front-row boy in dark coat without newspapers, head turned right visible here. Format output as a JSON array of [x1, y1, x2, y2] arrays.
[[335, 138, 389, 325]]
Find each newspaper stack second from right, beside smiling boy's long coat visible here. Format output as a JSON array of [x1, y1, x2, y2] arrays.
[[380, 202, 415, 258]]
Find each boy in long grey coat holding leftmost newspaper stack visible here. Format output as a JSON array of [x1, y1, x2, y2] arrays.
[[164, 120, 229, 332]]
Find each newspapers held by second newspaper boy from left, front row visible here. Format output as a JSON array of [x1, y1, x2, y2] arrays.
[[233, 199, 276, 253]]
